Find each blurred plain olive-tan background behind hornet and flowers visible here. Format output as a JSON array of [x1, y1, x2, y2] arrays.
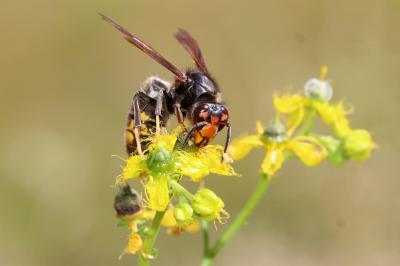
[[0, 0, 400, 266]]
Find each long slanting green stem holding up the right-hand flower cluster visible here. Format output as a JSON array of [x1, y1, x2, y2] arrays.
[[201, 174, 271, 266]]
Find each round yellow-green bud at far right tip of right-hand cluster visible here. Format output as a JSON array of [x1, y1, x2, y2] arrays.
[[343, 129, 376, 161]]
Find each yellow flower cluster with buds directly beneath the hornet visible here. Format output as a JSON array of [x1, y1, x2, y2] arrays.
[[114, 130, 237, 257]]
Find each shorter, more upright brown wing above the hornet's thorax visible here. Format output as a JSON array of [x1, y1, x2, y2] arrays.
[[175, 29, 208, 74]]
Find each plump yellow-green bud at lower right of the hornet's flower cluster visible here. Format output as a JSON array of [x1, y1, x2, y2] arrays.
[[192, 188, 227, 221]]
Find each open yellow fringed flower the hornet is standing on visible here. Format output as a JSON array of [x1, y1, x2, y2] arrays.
[[117, 131, 237, 211]]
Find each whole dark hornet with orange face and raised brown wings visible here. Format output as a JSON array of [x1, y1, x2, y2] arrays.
[[100, 14, 231, 155]]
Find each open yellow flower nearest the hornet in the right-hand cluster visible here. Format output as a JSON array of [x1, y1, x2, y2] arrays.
[[228, 121, 328, 176]]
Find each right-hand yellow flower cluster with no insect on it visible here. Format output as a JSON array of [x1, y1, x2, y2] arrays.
[[228, 66, 376, 176]]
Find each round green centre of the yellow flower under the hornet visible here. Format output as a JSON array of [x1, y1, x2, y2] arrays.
[[146, 146, 174, 174]]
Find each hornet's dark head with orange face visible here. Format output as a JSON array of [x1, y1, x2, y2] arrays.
[[192, 103, 229, 147]]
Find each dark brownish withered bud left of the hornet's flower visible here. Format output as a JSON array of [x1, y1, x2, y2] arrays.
[[114, 184, 141, 218]]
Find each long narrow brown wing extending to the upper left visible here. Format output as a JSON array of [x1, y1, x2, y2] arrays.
[[99, 13, 187, 81]]
